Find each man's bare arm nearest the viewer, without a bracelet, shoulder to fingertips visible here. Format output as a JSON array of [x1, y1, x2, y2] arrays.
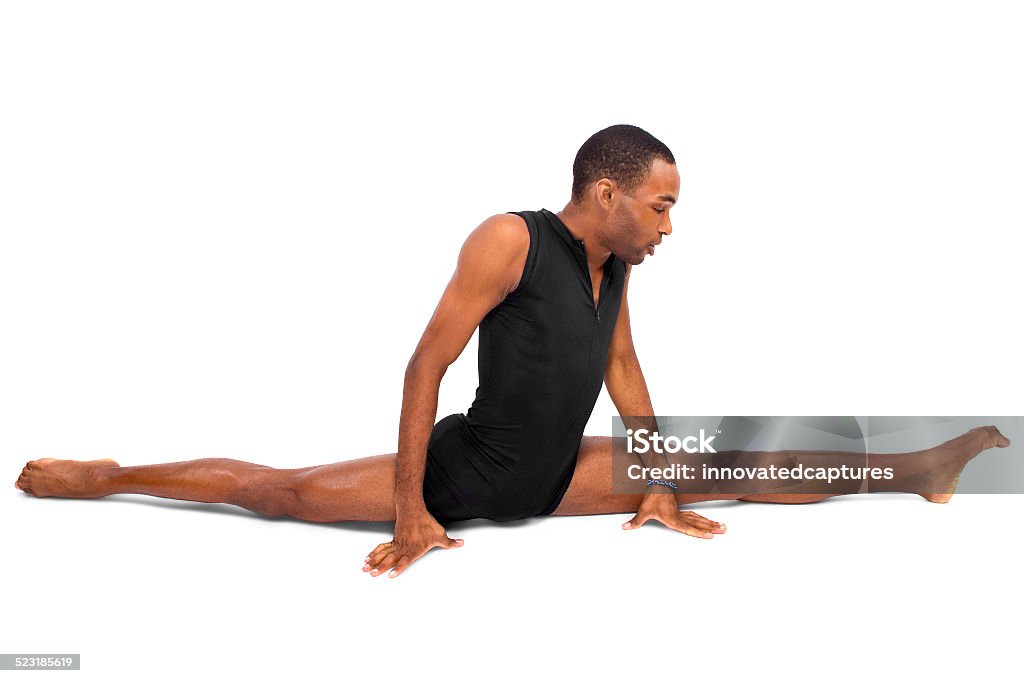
[[365, 214, 529, 575]]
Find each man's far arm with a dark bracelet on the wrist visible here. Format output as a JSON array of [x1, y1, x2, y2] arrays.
[[604, 264, 725, 539]]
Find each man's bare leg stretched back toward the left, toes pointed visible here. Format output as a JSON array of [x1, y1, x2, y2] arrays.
[[15, 453, 395, 522]]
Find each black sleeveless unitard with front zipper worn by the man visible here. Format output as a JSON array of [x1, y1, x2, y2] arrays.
[[423, 209, 626, 523]]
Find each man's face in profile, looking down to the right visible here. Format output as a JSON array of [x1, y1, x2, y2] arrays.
[[605, 159, 679, 265]]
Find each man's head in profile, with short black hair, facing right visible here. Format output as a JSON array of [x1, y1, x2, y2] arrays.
[[571, 124, 679, 265]]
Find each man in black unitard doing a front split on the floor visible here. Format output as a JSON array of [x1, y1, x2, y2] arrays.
[[15, 125, 1009, 577]]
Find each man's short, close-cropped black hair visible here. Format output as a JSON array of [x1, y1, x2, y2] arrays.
[[572, 123, 676, 204]]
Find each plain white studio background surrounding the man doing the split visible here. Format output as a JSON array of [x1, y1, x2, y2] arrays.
[[0, 0, 1024, 681]]
